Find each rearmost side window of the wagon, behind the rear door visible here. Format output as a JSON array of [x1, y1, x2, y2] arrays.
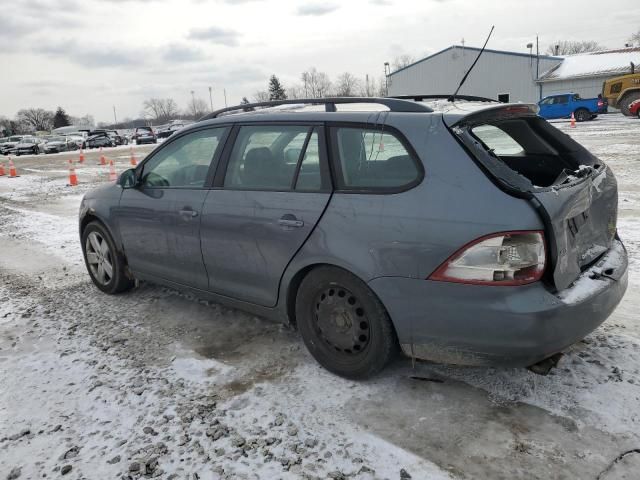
[[334, 127, 421, 189]]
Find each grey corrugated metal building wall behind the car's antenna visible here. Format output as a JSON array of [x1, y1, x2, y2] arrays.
[[389, 47, 560, 102]]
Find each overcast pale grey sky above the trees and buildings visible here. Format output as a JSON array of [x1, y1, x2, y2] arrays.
[[0, 0, 640, 121]]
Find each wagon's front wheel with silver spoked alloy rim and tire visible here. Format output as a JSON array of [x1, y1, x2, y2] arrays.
[[82, 221, 134, 295]]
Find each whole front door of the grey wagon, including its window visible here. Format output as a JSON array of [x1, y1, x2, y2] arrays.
[[118, 128, 226, 289]]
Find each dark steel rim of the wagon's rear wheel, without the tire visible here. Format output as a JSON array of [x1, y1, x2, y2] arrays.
[[314, 285, 370, 355]]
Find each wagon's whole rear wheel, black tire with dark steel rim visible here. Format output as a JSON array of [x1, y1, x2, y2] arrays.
[[295, 266, 398, 379]]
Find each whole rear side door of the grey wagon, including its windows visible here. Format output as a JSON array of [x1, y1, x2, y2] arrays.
[[201, 124, 331, 307]]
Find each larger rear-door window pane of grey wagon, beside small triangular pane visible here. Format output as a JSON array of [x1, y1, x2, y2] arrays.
[[224, 125, 310, 190]]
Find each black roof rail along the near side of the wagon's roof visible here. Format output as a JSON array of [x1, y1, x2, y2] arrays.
[[200, 97, 433, 121]]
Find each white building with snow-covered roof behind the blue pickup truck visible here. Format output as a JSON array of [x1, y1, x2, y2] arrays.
[[538, 47, 640, 98]]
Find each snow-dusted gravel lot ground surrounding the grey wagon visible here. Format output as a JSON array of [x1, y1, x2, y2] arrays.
[[0, 114, 640, 480]]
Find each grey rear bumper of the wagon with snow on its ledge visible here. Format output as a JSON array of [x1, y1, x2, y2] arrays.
[[369, 238, 627, 366]]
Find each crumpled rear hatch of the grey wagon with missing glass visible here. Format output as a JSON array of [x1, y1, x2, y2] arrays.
[[444, 104, 618, 290]]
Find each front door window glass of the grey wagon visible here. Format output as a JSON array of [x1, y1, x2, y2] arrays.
[[142, 128, 226, 188]]
